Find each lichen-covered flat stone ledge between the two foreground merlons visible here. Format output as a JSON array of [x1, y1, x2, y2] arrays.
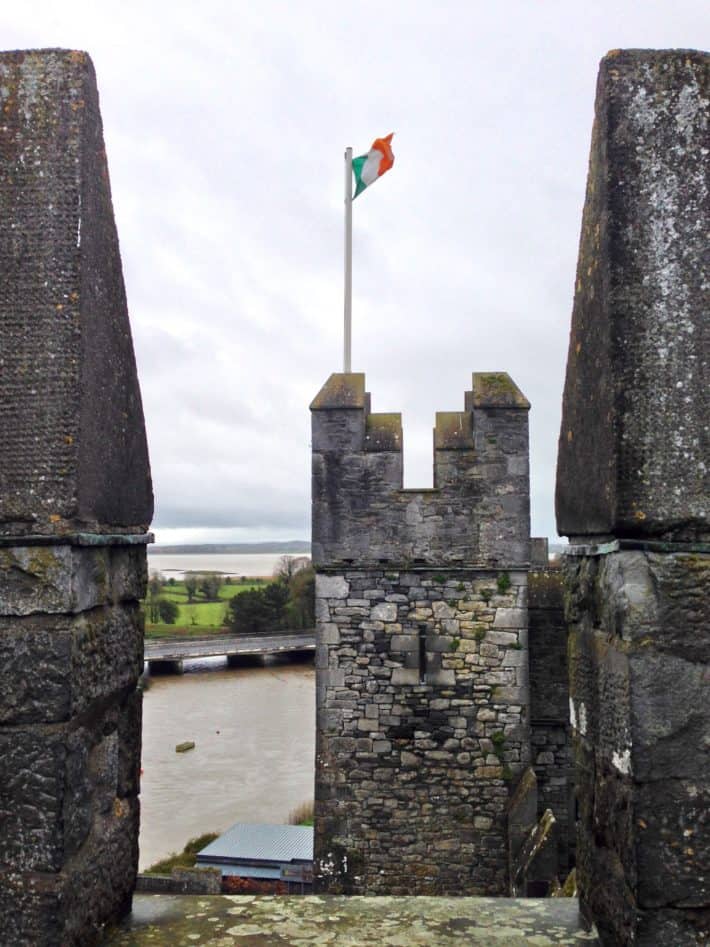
[[104, 895, 599, 947]]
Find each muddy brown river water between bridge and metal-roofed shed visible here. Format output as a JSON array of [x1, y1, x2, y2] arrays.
[[140, 658, 315, 870]]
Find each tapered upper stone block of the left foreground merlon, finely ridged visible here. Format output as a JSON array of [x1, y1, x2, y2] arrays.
[[0, 49, 153, 536]]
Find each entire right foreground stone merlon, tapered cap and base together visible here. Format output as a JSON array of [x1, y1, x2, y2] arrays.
[[557, 50, 710, 947]]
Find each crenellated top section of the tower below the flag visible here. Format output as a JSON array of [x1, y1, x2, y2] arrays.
[[311, 372, 530, 568]]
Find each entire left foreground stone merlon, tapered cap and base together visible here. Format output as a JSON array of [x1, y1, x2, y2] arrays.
[[0, 50, 152, 947]]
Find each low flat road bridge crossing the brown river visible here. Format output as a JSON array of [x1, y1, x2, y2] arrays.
[[145, 629, 316, 674]]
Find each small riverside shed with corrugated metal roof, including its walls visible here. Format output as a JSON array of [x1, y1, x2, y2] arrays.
[[197, 822, 313, 893]]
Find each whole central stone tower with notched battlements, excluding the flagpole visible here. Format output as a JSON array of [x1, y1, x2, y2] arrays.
[[312, 375, 529, 894]]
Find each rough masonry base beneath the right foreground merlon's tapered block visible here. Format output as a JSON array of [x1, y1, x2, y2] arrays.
[[565, 549, 710, 947]]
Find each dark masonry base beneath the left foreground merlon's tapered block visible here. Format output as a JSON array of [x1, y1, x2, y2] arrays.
[[0, 545, 146, 947]]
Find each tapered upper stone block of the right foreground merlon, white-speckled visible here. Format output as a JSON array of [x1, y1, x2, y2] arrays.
[[556, 50, 710, 539]]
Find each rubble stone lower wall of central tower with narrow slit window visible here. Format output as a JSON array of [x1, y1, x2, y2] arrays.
[[316, 570, 529, 894]]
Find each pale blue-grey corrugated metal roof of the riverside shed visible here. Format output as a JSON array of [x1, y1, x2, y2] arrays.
[[197, 822, 313, 863]]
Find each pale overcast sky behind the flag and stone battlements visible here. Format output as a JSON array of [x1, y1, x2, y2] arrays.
[[0, 0, 710, 542]]
